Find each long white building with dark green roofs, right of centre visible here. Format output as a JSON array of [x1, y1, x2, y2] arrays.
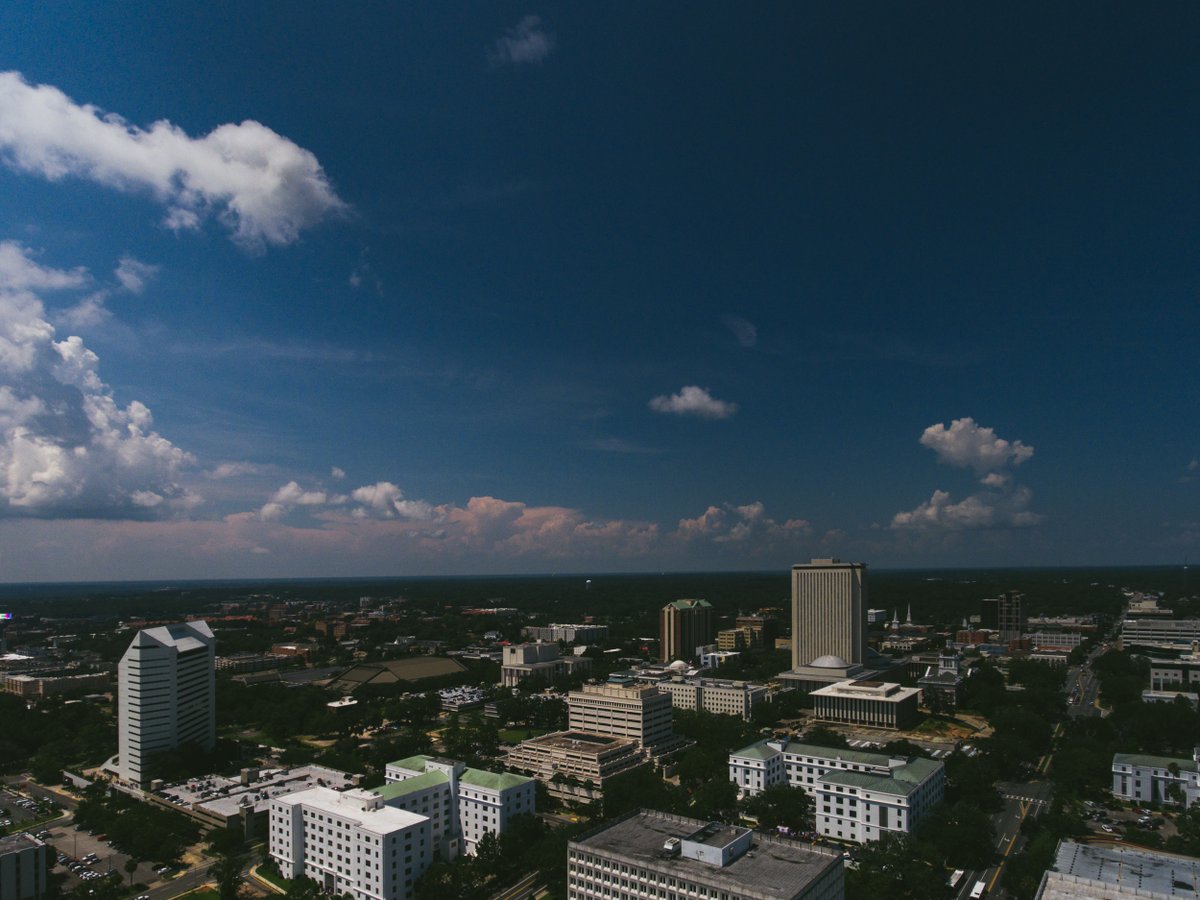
[[730, 740, 946, 844]]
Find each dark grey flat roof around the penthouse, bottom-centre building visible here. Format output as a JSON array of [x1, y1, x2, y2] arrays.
[[570, 810, 842, 900]]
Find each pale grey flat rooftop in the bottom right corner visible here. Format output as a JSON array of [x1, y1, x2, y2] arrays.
[[1038, 840, 1200, 900]]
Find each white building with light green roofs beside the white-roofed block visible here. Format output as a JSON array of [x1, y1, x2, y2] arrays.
[[376, 756, 536, 858]]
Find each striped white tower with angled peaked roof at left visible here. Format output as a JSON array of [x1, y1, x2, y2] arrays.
[[116, 622, 217, 785]]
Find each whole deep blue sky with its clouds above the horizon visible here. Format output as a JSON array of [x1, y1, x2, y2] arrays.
[[0, 2, 1200, 581]]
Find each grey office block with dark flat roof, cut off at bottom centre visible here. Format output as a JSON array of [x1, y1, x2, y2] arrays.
[[566, 810, 846, 900]]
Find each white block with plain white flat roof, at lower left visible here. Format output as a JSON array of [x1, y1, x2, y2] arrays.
[[268, 787, 433, 900]]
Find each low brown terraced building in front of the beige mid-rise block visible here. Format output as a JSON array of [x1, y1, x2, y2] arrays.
[[508, 731, 646, 800]]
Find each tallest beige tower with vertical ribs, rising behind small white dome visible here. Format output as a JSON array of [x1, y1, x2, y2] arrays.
[[792, 559, 866, 668]]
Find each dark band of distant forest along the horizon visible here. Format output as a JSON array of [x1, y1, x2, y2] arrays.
[[0, 566, 1200, 637]]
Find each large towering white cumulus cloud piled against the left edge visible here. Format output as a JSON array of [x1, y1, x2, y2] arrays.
[[0, 241, 199, 518]]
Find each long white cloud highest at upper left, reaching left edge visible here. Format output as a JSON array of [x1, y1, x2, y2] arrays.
[[0, 72, 346, 254]]
